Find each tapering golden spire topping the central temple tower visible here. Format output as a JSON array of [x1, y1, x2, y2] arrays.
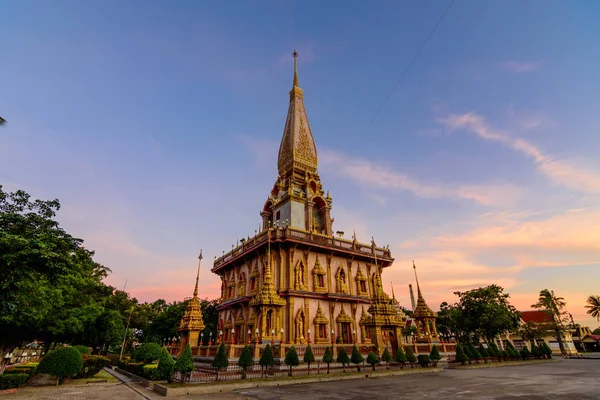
[[277, 50, 318, 176]]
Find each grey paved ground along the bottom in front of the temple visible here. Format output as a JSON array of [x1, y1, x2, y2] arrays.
[[4, 360, 600, 400]]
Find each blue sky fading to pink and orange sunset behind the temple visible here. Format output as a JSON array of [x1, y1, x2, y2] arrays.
[[0, 0, 600, 328]]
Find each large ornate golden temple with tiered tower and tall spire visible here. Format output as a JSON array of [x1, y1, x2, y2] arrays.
[[212, 52, 404, 352]]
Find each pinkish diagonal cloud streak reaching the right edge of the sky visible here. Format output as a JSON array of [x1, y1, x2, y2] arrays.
[[438, 112, 600, 193]]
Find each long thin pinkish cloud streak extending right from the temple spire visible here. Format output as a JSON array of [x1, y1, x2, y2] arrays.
[[319, 149, 521, 206]]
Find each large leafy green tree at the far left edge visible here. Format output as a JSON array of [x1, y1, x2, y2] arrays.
[[0, 186, 111, 362]]
